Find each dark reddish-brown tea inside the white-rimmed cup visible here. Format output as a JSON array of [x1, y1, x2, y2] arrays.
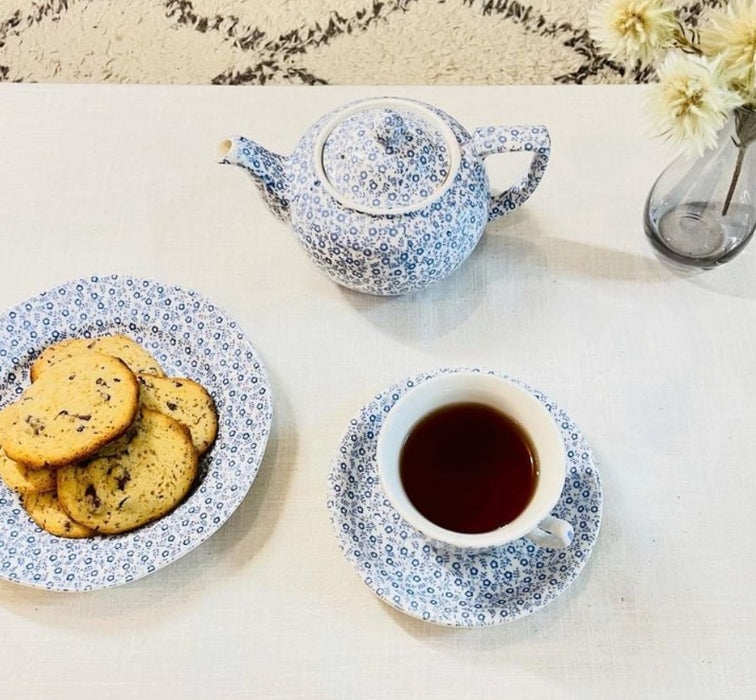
[[399, 402, 538, 533]]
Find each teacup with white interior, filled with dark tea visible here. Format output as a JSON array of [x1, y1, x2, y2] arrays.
[[376, 371, 574, 549]]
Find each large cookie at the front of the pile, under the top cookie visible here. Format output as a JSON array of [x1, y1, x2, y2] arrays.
[[58, 408, 198, 534]]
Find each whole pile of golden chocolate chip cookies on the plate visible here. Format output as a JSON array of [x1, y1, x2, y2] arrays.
[[0, 335, 218, 537]]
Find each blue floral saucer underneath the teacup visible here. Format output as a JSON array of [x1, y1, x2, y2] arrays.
[[328, 369, 602, 627]]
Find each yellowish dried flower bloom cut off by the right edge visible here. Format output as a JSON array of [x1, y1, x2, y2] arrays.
[[701, 0, 756, 99]]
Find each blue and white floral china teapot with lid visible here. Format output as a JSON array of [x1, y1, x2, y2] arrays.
[[219, 97, 551, 295]]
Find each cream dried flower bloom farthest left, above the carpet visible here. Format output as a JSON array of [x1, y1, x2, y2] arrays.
[[590, 0, 678, 63]]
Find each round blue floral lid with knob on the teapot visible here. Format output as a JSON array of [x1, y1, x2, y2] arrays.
[[315, 98, 460, 214]]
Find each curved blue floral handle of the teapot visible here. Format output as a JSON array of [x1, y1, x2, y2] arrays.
[[472, 125, 551, 221]]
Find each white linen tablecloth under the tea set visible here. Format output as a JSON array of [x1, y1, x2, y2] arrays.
[[0, 84, 756, 699]]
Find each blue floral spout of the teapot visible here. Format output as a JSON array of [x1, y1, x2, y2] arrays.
[[218, 136, 289, 223]]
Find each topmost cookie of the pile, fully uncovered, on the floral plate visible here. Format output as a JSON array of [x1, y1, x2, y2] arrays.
[[0, 352, 139, 469]]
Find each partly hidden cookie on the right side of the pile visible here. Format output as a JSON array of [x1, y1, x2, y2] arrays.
[[137, 374, 218, 454]]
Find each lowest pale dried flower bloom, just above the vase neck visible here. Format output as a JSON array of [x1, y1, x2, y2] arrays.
[[650, 52, 743, 154]]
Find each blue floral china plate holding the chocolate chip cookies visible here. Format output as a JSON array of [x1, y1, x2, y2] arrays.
[[0, 275, 272, 591]]
